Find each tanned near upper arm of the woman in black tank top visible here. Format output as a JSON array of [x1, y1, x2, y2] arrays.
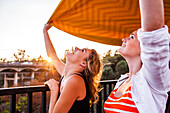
[[53, 76, 84, 113]]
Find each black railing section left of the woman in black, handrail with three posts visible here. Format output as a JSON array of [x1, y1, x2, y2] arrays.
[[0, 85, 50, 113]]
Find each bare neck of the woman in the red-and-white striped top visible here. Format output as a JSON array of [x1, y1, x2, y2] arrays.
[[126, 56, 142, 75]]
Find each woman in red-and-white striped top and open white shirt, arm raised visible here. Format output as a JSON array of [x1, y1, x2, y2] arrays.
[[104, 0, 170, 113]]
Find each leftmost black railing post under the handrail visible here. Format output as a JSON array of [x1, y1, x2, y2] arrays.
[[10, 94, 16, 113]]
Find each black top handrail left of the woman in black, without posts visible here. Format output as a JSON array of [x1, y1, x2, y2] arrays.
[[0, 85, 50, 96]]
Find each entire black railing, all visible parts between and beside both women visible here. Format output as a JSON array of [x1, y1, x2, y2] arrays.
[[0, 80, 170, 113]]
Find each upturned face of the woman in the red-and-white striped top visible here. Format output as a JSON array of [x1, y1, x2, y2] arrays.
[[119, 31, 141, 57]]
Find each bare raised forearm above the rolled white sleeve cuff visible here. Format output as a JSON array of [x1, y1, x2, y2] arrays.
[[139, 0, 164, 31]]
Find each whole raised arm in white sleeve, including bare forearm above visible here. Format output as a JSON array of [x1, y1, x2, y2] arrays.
[[137, 0, 170, 91]]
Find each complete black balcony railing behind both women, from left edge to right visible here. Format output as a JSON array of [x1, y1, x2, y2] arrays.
[[0, 80, 170, 113]]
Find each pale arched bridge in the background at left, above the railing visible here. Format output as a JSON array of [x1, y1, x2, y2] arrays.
[[0, 62, 51, 88]]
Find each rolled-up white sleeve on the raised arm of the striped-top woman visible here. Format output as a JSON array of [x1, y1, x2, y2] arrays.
[[137, 26, 170, 91]]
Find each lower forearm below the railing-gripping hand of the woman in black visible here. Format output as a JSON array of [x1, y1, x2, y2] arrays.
[[49, 92, 58, 113]]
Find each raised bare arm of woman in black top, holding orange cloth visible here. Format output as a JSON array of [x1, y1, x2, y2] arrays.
[[43, 24, 65, 76]]
